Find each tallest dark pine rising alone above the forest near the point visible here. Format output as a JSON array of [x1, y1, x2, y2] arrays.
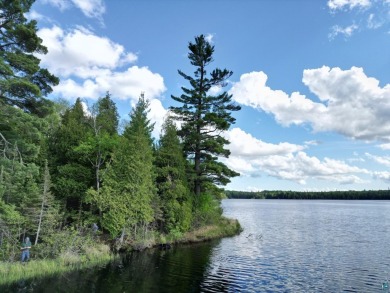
[[171, 35, 241, 196]]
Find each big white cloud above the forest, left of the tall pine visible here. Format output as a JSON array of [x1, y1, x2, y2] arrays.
[[38, 26, 166, 100]]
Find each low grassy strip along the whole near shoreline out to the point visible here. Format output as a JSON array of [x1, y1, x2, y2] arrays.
[[0, 217, 242, 286]]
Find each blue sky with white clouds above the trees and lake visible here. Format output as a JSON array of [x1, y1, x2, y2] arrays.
[[26, 0, 390, 191]]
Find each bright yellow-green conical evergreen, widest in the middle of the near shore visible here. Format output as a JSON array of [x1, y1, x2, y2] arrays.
[[92, 96, 156, 241]]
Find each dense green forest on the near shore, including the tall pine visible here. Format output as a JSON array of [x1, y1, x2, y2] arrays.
[[0, 0, 240, 260]]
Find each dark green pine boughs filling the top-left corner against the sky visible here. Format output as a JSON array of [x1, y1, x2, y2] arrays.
[[0, 0, 59, 115]]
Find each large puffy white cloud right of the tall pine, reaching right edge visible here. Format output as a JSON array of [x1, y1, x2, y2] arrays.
[[230, 66, 390, 141]]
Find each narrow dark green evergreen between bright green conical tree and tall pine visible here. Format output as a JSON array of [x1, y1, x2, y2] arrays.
[[156, 117, 192, 232]]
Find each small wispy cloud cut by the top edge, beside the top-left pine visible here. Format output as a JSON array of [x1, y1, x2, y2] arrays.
[[41, 0, 106, 21]]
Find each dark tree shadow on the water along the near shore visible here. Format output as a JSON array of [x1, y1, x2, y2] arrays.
[[0, 240, 221, 293]]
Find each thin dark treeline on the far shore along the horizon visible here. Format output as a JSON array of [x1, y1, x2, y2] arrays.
[[225, 190, 390, 200]]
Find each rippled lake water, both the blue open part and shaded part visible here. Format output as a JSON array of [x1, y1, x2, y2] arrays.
[[4, 199, 390, 293]]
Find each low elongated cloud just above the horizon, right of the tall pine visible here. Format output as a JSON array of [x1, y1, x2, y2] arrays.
[[223, 128, 368, 184]]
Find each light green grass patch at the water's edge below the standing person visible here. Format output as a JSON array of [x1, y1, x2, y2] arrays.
[[0, 242, 114, 285]]
